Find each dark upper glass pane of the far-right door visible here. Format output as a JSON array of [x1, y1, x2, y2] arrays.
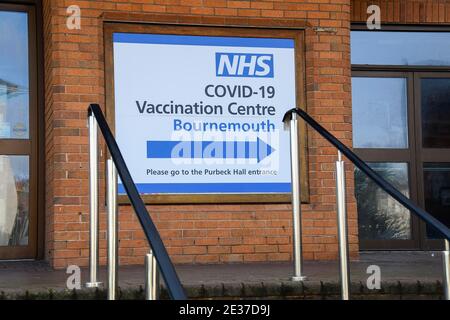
[[420, 78, 450, 148]]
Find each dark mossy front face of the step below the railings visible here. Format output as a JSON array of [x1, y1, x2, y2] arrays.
[[0, 281, 444, 300]]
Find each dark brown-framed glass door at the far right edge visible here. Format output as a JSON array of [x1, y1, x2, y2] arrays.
[[414, 72, 450, 249]]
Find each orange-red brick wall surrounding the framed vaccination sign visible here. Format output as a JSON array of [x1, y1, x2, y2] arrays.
[[44, 0, 358, 268]]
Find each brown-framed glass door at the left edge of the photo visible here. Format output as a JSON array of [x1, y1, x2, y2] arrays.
[[0, 4, 37, 260]]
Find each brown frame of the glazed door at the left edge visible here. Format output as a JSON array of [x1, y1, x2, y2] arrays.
[[0, 1, 45, 260]]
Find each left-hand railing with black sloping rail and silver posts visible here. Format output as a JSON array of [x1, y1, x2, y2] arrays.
[[87, 104, 186, 300]]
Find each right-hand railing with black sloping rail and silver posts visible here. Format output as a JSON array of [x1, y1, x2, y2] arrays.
[[283, 108, 450, 300]]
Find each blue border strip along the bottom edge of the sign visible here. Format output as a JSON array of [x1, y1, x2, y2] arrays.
[[118, 182, 291, 194]]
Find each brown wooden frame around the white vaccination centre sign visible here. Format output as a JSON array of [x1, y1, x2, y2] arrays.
[[103, 20, 309, 204]]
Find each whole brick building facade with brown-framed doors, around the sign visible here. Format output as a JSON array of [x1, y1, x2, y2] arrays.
[[0, 0, 450, 268]]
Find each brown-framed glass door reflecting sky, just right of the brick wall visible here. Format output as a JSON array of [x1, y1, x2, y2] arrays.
[[352, 71, 419, 250]]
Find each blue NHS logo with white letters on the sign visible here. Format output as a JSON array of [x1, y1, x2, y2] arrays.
[[216, 52, 273, 78]]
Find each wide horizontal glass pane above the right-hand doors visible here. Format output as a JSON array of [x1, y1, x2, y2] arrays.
[[350, 31, 450, 66]]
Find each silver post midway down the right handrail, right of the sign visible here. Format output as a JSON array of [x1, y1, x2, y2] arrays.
[[336, 151, 350, 300]]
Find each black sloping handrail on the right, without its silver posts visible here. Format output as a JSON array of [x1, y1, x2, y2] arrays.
[[283, 108, 450, 240]]
